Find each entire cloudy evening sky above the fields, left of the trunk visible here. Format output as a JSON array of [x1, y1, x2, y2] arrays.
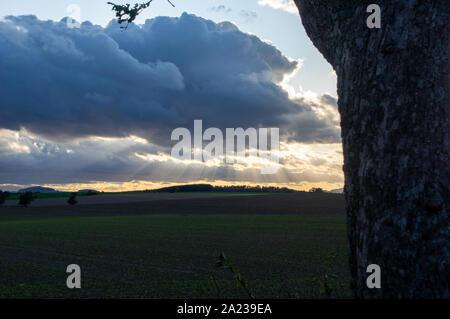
[[0, 0, 343, 191]]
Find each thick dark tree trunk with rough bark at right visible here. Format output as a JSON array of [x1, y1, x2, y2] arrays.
[[295, 0, 450, 298]]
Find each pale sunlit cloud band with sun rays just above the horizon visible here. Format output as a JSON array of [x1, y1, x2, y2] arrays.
[[0, 130, 343, 188]]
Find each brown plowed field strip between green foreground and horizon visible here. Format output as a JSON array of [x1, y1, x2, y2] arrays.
[[0, 193, 345, 217]]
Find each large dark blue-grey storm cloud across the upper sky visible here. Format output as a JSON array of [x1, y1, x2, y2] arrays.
[[0, 14, 339, 146]]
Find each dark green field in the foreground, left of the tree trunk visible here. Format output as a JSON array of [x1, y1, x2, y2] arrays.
[[0, 215, 350, 298]]
